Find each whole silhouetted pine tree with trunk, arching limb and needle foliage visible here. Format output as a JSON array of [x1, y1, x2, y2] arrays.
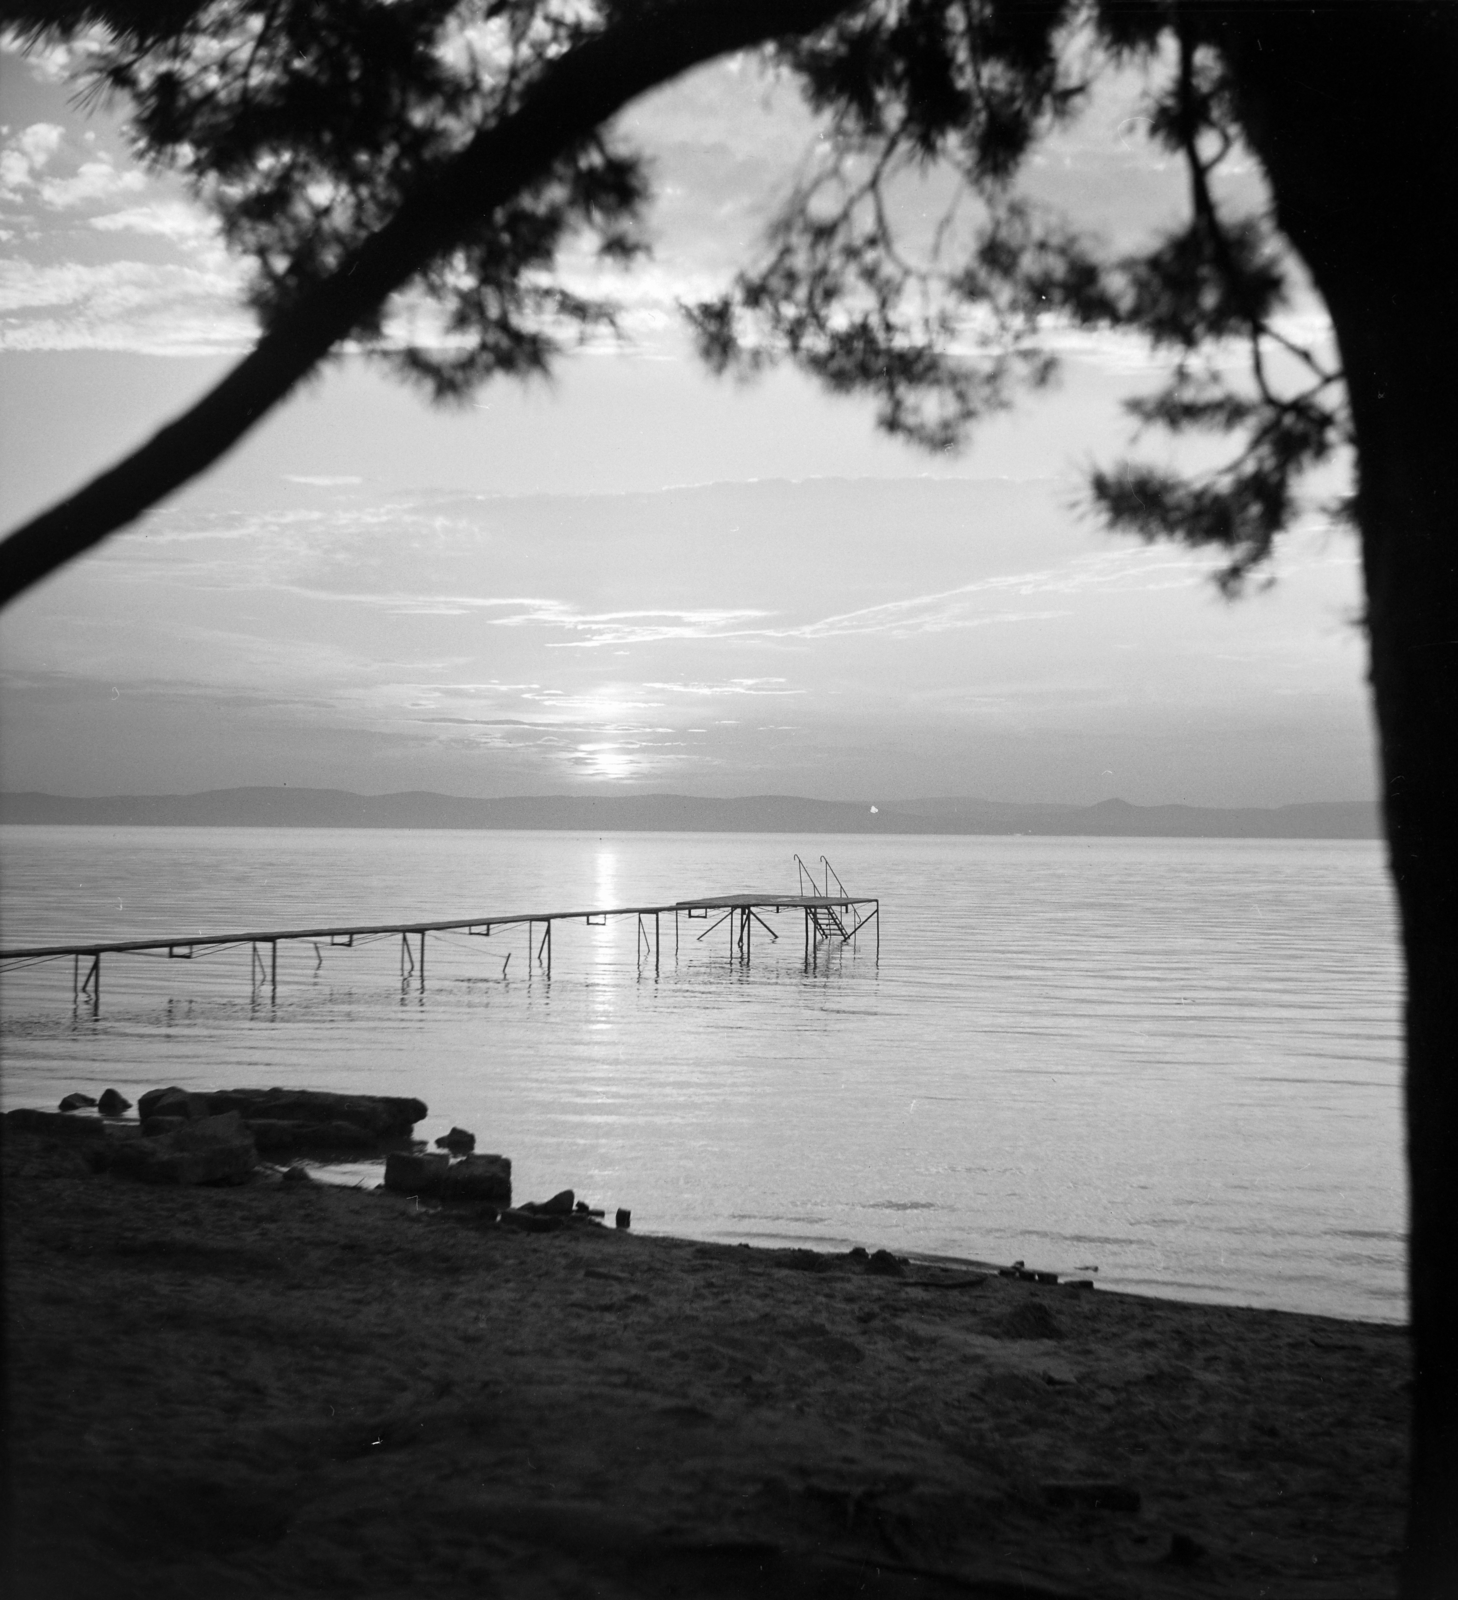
[[0, 0, 1458, 1597]]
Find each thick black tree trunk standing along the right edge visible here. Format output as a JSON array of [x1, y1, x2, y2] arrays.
[[1221, 6, 1458, 1600]]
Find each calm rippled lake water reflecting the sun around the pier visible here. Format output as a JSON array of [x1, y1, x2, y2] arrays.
[[0, 827, 1405, 1320]]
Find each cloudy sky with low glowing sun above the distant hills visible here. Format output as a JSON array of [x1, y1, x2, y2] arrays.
[[0, 23, 1375, 805]]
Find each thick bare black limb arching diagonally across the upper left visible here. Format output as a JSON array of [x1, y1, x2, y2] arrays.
[[0, 0, 848, 605]]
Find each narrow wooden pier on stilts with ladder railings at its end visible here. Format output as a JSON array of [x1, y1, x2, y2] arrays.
[[0, 856, 880, 1011]]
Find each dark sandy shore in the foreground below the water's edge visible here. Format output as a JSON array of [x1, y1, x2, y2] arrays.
[[3, 1134, 1408, 1600]]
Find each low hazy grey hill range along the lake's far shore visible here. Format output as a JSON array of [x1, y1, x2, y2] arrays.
[[0, 789, 1381, 838]]
